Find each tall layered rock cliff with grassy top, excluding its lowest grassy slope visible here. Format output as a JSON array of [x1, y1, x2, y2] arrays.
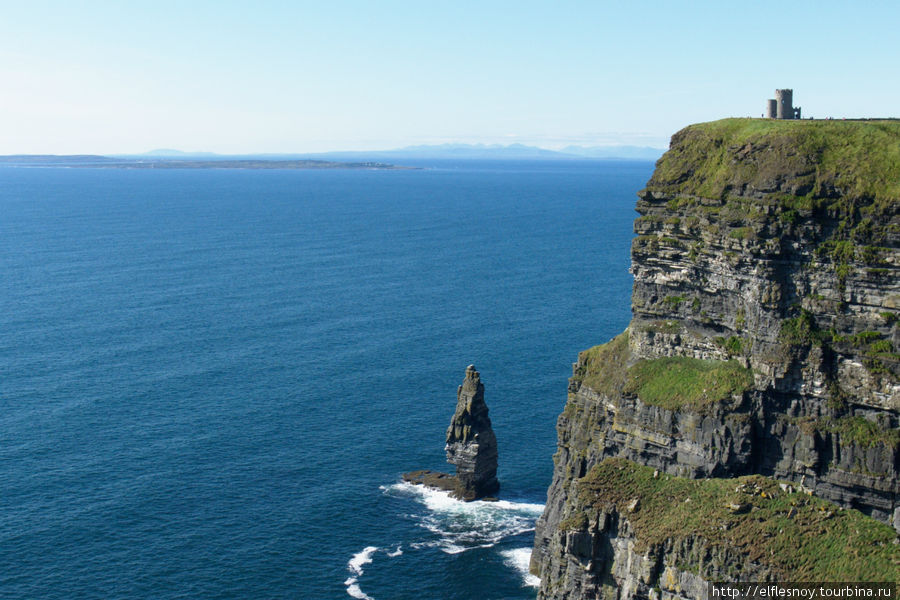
[[532, 119, 900, 598]]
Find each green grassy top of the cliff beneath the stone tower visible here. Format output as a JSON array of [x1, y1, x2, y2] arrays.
[[647, 119, 900, 208]]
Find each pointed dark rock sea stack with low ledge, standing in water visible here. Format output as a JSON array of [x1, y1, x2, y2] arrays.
[[403, 365, 500, 502]]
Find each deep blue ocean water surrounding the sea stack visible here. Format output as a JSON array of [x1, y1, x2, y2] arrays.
[[0, 161, 652, 600]]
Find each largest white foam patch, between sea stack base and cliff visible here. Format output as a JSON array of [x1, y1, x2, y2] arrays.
[[382, 482, 544, 554]]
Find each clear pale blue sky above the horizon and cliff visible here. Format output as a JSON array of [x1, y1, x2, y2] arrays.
[[0, 0, 900, 154]]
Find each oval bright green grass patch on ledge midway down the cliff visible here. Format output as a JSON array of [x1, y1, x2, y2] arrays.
[[624, 356, 753, 410]]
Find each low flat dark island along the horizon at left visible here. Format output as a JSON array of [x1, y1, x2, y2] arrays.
[[0, 154, 404, 170]]
